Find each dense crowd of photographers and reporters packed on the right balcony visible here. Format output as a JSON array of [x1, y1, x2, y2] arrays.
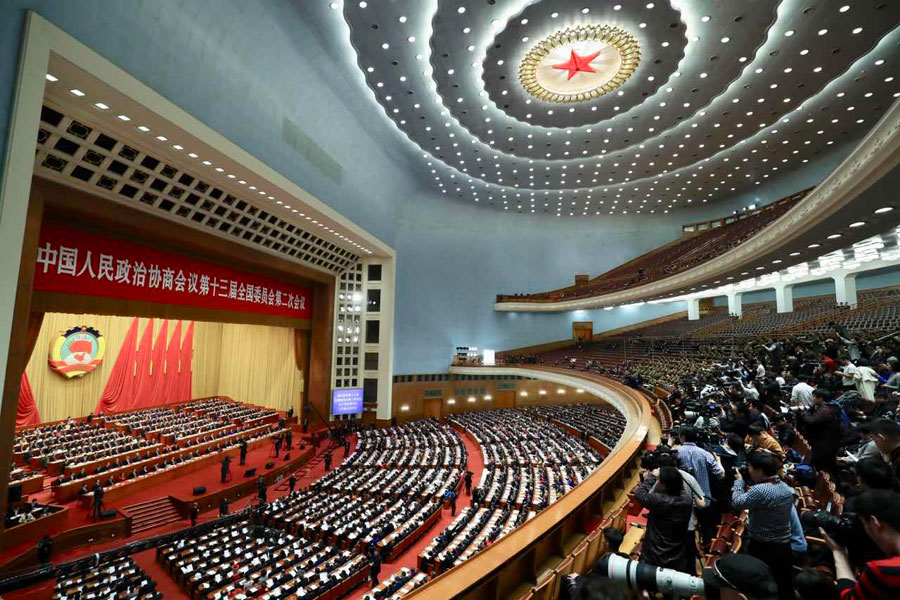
[[588, 327, 900, 600]]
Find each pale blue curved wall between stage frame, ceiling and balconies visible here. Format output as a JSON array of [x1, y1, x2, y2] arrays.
[[0, 0, 850, 373]]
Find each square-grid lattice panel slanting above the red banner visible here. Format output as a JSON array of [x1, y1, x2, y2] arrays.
[[35, 105, 359, 274]]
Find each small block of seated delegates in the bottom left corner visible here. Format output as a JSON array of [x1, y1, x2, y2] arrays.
[[53, 555, 163, 600]]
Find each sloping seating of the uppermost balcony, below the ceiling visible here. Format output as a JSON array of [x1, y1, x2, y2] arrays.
[[497, 190, 810, 302]]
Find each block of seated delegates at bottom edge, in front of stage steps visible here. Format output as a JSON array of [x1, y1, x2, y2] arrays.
[[157, 520, 367, 600]]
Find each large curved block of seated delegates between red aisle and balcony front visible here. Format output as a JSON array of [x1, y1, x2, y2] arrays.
[[419, 410, 602, 572]]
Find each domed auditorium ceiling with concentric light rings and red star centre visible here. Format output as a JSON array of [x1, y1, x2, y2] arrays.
[[326, 0, 900, 217]]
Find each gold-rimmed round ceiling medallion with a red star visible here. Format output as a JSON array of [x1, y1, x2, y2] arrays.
[[519, 25, 641, 103]]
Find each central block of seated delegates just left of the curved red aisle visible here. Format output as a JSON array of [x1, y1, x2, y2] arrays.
[[264, 420, 458, 558]]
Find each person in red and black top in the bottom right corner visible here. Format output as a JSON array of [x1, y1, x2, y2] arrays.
[[822, 490, 900, 600]]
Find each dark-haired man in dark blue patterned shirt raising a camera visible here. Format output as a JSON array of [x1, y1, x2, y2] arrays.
[[731, 452, 794, 599]]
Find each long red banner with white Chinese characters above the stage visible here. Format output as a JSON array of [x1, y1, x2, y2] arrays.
[[34, 225, 312, 319]]
